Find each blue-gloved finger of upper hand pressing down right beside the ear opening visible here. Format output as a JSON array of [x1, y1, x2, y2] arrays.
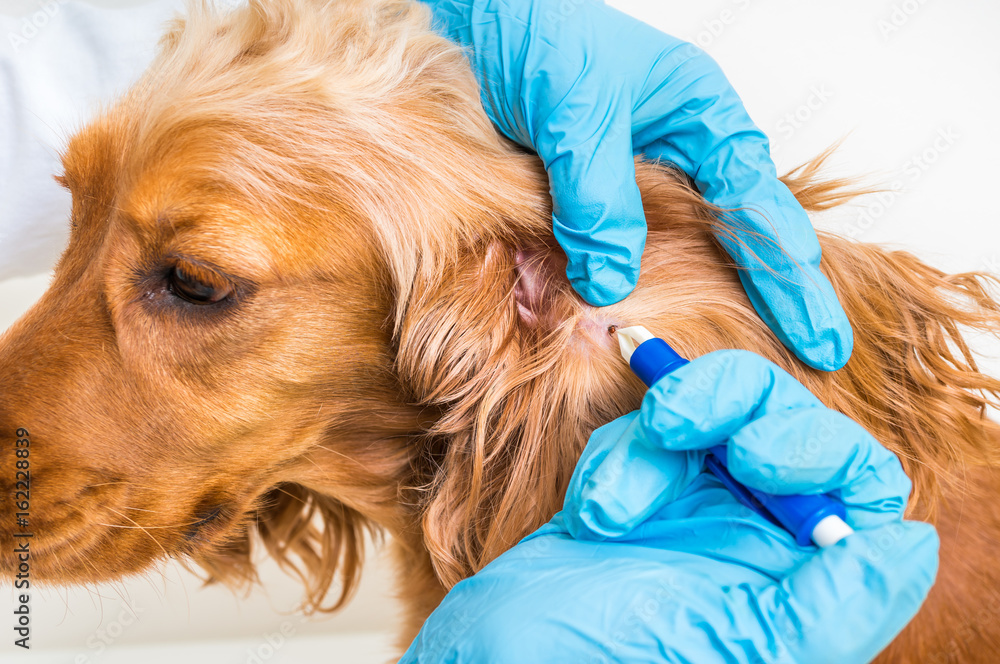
[[522, 4, 658, 306]]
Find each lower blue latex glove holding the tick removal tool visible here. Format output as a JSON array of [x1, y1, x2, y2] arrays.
[[402, 351, 938, 664]]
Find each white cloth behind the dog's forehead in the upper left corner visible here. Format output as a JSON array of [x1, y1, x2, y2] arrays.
[[0, 0, 193, 280]]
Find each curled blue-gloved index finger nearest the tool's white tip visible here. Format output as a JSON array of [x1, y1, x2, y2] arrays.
[[639, 350, 825, 450]]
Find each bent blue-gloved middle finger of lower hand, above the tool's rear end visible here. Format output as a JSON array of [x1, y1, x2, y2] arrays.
[[727, 407, 912, 528]]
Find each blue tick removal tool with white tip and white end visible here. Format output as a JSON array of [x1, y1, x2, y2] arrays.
[[616, 325, 854, 546]]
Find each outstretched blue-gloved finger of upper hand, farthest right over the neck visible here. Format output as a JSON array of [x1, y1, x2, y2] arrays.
[[633, 44, 854, 371]]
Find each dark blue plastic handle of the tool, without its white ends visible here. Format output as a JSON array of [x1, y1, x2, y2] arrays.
[[629, 337, 847, 546]]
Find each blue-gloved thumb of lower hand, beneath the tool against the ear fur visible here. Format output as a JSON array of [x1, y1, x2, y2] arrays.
[[560, 411, 704, 541]]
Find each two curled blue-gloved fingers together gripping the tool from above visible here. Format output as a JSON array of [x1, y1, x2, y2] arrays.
[[640, 351, 911, 528]]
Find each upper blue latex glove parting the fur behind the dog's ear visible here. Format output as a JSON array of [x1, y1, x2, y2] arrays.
[[426, 0, 854, 371]]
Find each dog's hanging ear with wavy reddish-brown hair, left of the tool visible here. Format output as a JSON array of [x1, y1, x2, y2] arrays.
[[396, 235, 638, 588]]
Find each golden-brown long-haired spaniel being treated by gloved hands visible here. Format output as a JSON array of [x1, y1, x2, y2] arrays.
[[0, 0, 1000, 662]]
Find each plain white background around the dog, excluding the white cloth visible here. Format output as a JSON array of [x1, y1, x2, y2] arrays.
[[0, 0, 1000, 664]]
